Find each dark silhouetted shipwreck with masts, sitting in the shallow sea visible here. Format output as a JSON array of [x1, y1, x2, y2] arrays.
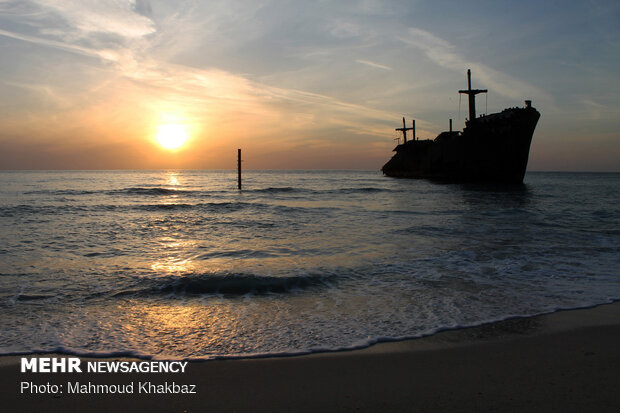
[[381, 70, 540, 183]]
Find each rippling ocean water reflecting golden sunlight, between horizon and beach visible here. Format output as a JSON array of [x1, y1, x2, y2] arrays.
[[0, 171, 620, 359]]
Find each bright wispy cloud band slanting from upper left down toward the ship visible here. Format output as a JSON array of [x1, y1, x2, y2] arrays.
[[0, 0, 398, 146]]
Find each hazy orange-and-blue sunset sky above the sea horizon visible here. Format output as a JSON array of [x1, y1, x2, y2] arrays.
[[0, 0, 620, 171]]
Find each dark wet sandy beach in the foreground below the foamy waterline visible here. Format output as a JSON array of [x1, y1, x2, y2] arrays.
[[0, 303, 620, 412]]
